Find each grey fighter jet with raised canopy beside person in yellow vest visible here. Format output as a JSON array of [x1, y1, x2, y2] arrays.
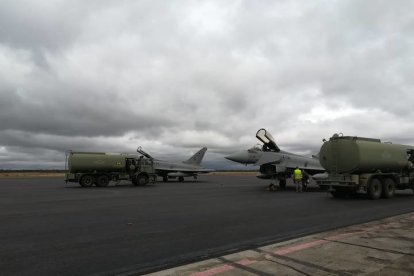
[[225, 128, 325, 189]]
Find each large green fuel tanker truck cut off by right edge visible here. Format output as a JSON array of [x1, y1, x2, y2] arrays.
[[317, 134, 414, 199]]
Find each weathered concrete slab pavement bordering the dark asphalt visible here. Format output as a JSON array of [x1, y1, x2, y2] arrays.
[[150, 213, 414, 276]]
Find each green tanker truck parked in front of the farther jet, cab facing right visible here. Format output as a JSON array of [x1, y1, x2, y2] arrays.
[[65, 151, 156, 187]]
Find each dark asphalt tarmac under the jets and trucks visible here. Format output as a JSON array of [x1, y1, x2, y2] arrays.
[[0, 175, 414, 275]]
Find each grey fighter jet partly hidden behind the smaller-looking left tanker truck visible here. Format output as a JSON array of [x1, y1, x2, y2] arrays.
[[137, 147, 214, 182]]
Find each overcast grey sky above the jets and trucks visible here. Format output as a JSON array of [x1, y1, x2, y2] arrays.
[[0, 0, 414, 169]]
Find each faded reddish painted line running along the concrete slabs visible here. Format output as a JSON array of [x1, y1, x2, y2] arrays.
[[190, 215, 414, 276]]
